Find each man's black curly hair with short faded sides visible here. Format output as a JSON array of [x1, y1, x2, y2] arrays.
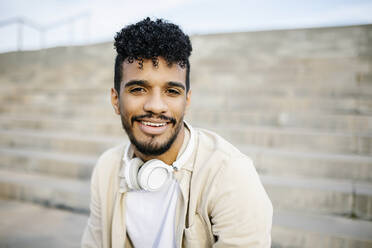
[[114, 17, 192, 95]]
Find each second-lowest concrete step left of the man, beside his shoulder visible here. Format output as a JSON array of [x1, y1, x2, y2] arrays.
[[0, 148, 99, 180]]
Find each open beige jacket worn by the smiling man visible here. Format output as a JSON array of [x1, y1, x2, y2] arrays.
[[82, 129, 273, 248]]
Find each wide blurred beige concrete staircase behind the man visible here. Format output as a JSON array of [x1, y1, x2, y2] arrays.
[[0, 25, 372, 247]]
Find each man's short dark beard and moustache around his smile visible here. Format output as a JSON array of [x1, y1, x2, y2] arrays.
[[121, 114, 183, 156]]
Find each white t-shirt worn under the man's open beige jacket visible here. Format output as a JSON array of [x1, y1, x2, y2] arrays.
[[126, 128, 190, 248]]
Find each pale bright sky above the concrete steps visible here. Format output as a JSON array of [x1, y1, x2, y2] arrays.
[[0, 0, 372, 52]]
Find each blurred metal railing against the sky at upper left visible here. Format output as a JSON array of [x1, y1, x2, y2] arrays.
[[0, 11, 91, 51]]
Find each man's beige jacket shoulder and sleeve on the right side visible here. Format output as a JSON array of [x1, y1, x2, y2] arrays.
[[193, 130, 273, 247]]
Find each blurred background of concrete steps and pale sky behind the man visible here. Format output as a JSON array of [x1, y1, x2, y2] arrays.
[[0, 0, 372, 247]]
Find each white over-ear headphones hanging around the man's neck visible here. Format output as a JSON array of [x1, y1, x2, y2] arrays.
[[123, 121, 195, 191]]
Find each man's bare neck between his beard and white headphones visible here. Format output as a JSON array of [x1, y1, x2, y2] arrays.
[[134, 125, 185, 165]]
